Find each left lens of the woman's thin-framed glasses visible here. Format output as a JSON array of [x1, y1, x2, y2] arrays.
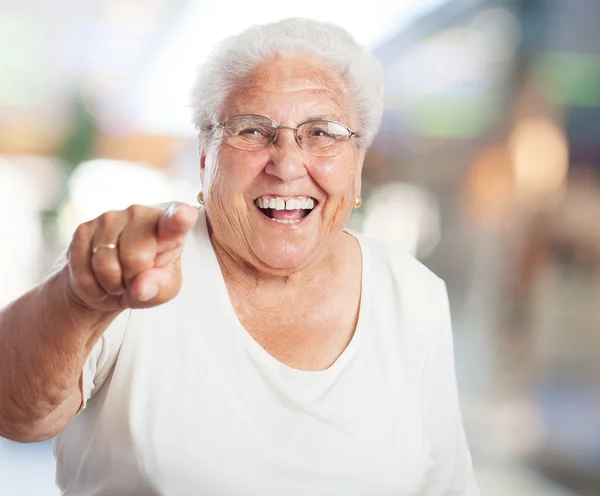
[[223, 115, 277, 150]]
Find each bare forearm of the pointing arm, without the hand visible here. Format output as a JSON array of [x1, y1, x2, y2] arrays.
[[0, 269, 118, 441]]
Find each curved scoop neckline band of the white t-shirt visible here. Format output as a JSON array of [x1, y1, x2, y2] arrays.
[[198, 207, 370, 380]]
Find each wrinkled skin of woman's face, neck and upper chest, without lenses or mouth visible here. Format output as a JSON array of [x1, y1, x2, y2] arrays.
[[201, 58, 365, 370]]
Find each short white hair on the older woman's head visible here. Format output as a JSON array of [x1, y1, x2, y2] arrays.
[[191, 18, 383, 149]]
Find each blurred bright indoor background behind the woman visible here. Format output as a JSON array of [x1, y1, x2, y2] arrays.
[[0, 0, 600, 496]]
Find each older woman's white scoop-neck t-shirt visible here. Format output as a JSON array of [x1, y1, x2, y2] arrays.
[[55, 207, 479, 496]]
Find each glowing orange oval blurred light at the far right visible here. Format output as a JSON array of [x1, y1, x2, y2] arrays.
[[509, 117, 569, 205]]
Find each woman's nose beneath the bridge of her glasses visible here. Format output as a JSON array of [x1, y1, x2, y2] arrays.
[[265, 128, 307, 182]]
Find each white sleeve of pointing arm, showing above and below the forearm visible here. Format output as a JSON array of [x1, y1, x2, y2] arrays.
[[44, 253, 131, 414]]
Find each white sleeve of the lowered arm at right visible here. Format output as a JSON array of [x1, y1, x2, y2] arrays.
[[420, 281, 480, 496]]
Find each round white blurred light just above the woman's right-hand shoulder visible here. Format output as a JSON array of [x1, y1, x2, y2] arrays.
[[362, 182, 440, 258]]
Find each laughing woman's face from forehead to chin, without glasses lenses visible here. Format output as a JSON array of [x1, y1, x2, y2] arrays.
[[202, 57, 365, 275]]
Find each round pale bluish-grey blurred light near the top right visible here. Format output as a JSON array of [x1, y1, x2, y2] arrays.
[[471, 7, 522, 62]]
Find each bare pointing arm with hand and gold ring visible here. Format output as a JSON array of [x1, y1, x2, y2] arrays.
[[0, 204, 197, 442]]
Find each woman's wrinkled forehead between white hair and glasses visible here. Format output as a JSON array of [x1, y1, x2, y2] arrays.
[[221, 56, 354, 124]]
